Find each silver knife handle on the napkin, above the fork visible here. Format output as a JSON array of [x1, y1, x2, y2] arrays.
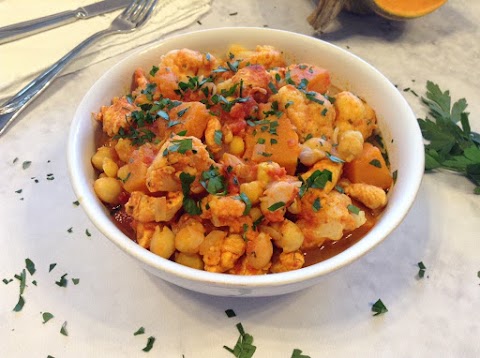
[[0, 9, 81, 44]]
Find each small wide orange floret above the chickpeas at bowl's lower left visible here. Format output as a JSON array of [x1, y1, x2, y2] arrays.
[[125, 191, 183, 223]]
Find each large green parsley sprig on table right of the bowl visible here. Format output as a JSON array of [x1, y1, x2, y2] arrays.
[[418, 81, 480, 194]]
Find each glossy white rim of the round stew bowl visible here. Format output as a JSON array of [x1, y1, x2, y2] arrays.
[[67, 27, 424, 288]]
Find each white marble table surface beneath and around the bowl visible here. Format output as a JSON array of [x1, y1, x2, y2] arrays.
[[0, 0, 480, 358]]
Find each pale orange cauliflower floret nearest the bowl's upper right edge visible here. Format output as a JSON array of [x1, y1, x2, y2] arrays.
[[334, 91, 377, 139]]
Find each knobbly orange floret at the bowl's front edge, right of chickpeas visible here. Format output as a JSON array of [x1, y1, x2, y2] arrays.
[[199, 230, 246, 272]]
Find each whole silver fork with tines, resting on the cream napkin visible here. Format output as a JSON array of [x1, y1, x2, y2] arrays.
[[0, 0, 158, 135]]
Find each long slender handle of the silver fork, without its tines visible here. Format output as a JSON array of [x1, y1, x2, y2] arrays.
[[0, 28, 117, 135]]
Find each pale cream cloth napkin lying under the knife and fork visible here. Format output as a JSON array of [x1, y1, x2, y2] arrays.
[[0, 0, 211, 98]]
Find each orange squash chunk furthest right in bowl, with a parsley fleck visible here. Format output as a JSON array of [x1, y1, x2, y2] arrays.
[[343, 142, 393, 189]]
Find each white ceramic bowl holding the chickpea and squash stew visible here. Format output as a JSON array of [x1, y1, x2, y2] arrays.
[[68, 28, 424, 296]]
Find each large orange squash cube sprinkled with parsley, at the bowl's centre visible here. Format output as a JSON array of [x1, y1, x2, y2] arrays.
[[243, 114, 300, 175]]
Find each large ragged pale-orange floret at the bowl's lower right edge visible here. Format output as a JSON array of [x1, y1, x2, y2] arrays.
[[297, 189, 366, 249]]
